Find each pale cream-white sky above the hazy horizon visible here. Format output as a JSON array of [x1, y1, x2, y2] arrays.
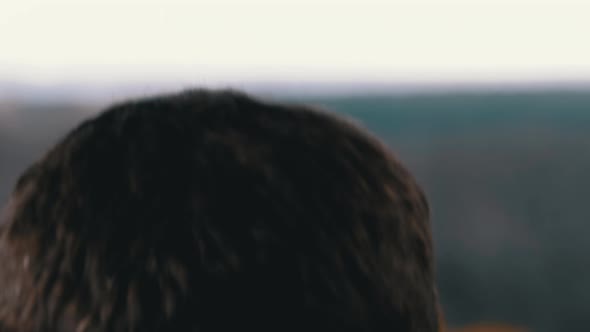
[[0, 0, 590, 82]]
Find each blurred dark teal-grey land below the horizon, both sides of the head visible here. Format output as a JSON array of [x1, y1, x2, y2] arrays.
[[0, 90, 590, 332]]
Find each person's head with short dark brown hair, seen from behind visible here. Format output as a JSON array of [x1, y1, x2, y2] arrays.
[[0, 90, 438, 332]]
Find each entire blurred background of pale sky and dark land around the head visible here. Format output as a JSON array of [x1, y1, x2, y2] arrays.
[[0, 0, 590, 332]]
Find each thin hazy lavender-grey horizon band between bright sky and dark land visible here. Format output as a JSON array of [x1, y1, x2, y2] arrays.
[[0, 79, 590, 101]]
